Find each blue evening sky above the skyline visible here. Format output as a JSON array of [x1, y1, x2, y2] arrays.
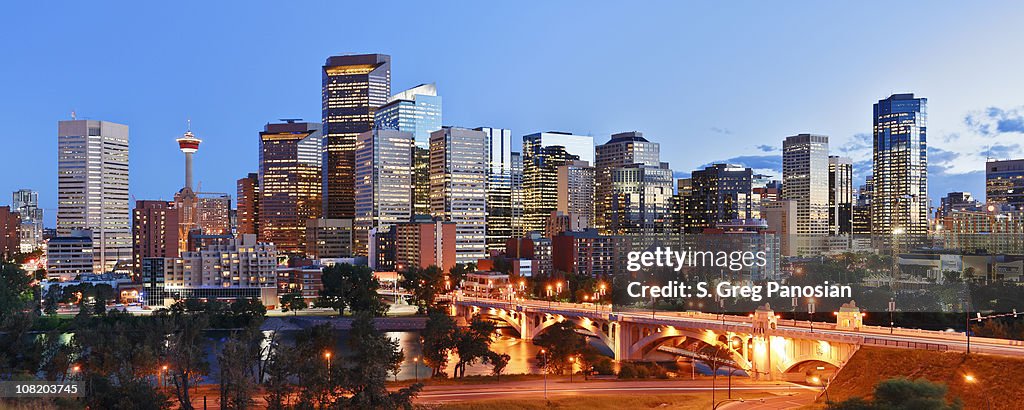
[[0, 1, 1024, 224]]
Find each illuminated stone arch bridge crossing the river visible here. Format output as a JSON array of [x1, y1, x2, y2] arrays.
[[452, 297, 1024, 379]]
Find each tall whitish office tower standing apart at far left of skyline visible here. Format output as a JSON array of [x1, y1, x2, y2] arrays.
[[57, 120, 132, 273]]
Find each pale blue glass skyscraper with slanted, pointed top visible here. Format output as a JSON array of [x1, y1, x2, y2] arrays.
[[374, 84, 441, 215]]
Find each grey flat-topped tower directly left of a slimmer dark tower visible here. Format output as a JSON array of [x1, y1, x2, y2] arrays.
[[782, 134, 829, 236]]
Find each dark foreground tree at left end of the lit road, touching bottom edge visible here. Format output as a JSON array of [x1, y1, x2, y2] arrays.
[[339, 312, 423, 409]]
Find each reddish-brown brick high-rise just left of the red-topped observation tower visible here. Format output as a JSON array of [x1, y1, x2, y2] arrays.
[[131, 200, 179, 274]]
